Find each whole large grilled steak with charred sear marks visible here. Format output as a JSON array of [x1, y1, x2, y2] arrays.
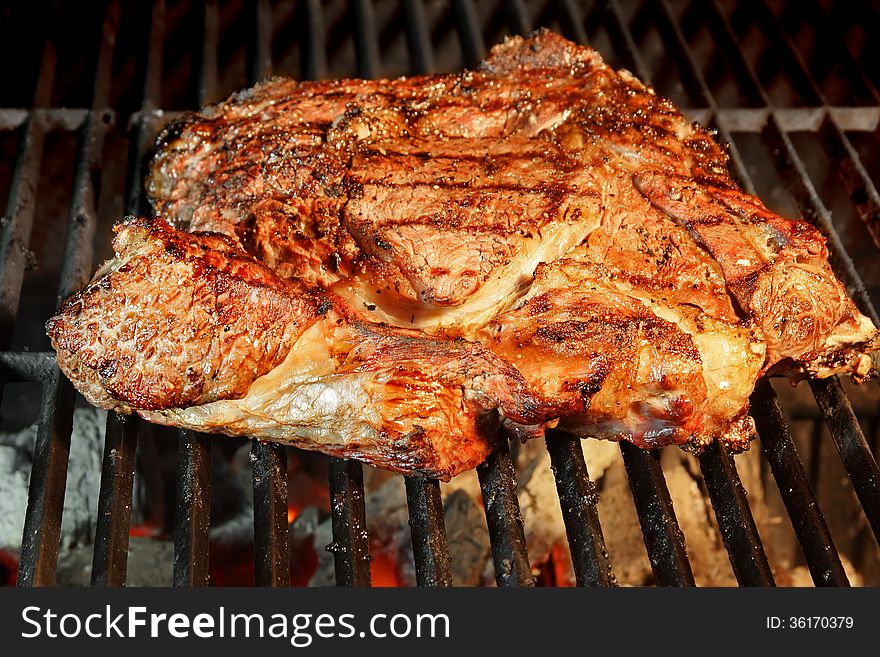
[[48, 32, 878, 478]]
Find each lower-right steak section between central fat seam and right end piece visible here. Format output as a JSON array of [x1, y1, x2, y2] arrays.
[[484, 167, 765, 446]]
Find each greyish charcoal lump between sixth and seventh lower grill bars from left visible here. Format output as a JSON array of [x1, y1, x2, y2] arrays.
[[443, 489, 491, 586]]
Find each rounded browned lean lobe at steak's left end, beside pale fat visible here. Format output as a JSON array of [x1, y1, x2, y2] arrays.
[[47, 219, 327, 410]]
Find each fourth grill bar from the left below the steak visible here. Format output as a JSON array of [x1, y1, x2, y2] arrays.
[[251, 440, 290, 586]]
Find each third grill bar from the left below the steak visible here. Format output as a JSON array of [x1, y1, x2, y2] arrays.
[[172, 430, 211, 586]]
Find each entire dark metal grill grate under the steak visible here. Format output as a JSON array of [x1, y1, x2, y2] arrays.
[[0, 0, 880, 586]]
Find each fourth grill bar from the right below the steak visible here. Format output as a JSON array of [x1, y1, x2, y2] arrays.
[[620, 442, 694, 586]]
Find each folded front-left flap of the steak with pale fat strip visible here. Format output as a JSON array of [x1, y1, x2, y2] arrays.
[[48, 219, 546, 479]]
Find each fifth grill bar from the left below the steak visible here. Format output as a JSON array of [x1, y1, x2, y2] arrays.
[[327, 458, 372, 586]]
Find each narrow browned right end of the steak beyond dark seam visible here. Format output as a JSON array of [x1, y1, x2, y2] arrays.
[[634, 172, 877, 378]]
